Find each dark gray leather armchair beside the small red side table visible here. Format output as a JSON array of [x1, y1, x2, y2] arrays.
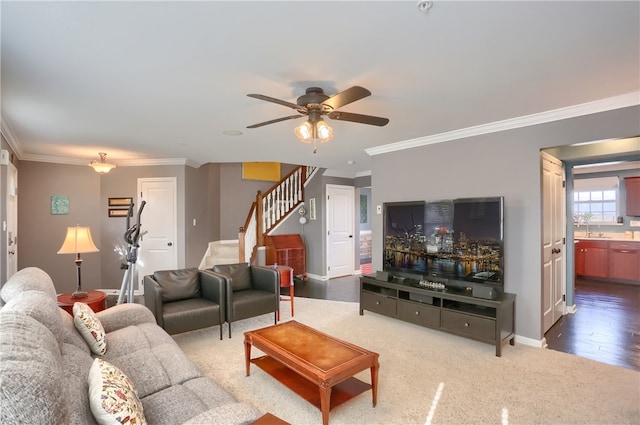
[[211, 263, 280, 338]]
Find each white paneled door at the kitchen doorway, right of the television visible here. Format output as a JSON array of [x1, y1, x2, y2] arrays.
[[541, 152, 566, 332]]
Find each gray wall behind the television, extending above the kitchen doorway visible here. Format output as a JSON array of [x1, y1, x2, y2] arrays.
[[372, 106, 640, 340]]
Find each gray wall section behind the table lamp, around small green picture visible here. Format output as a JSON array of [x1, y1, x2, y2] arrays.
[[18, 161, 102, 292]]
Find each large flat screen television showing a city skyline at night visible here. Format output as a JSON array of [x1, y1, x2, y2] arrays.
[[383, 196, 504, 288]]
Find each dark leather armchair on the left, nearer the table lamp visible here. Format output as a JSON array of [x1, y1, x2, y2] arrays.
[[144, 268, 226, 339]]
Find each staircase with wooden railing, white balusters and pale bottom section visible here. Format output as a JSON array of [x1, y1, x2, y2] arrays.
[[199, 165, 317, 269]]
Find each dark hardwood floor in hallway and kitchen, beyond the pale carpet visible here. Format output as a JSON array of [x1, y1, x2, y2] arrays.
[[295, 276, 640, 371]]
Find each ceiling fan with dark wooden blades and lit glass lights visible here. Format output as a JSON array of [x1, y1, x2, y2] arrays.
[[247, 86, 389, 153]]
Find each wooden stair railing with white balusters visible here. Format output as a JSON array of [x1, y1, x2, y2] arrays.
[[238, 165, 317, 264]]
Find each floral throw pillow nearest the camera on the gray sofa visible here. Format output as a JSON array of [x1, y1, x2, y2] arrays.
[[89, 358, 147, 425]]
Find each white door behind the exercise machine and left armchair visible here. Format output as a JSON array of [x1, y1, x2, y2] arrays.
[[138, 177, 178, 292]]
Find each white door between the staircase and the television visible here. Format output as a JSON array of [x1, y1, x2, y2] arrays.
[[327, 184, 355, 279]]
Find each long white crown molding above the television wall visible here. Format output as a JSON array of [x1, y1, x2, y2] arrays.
[[365, 91, 640, 156]]
